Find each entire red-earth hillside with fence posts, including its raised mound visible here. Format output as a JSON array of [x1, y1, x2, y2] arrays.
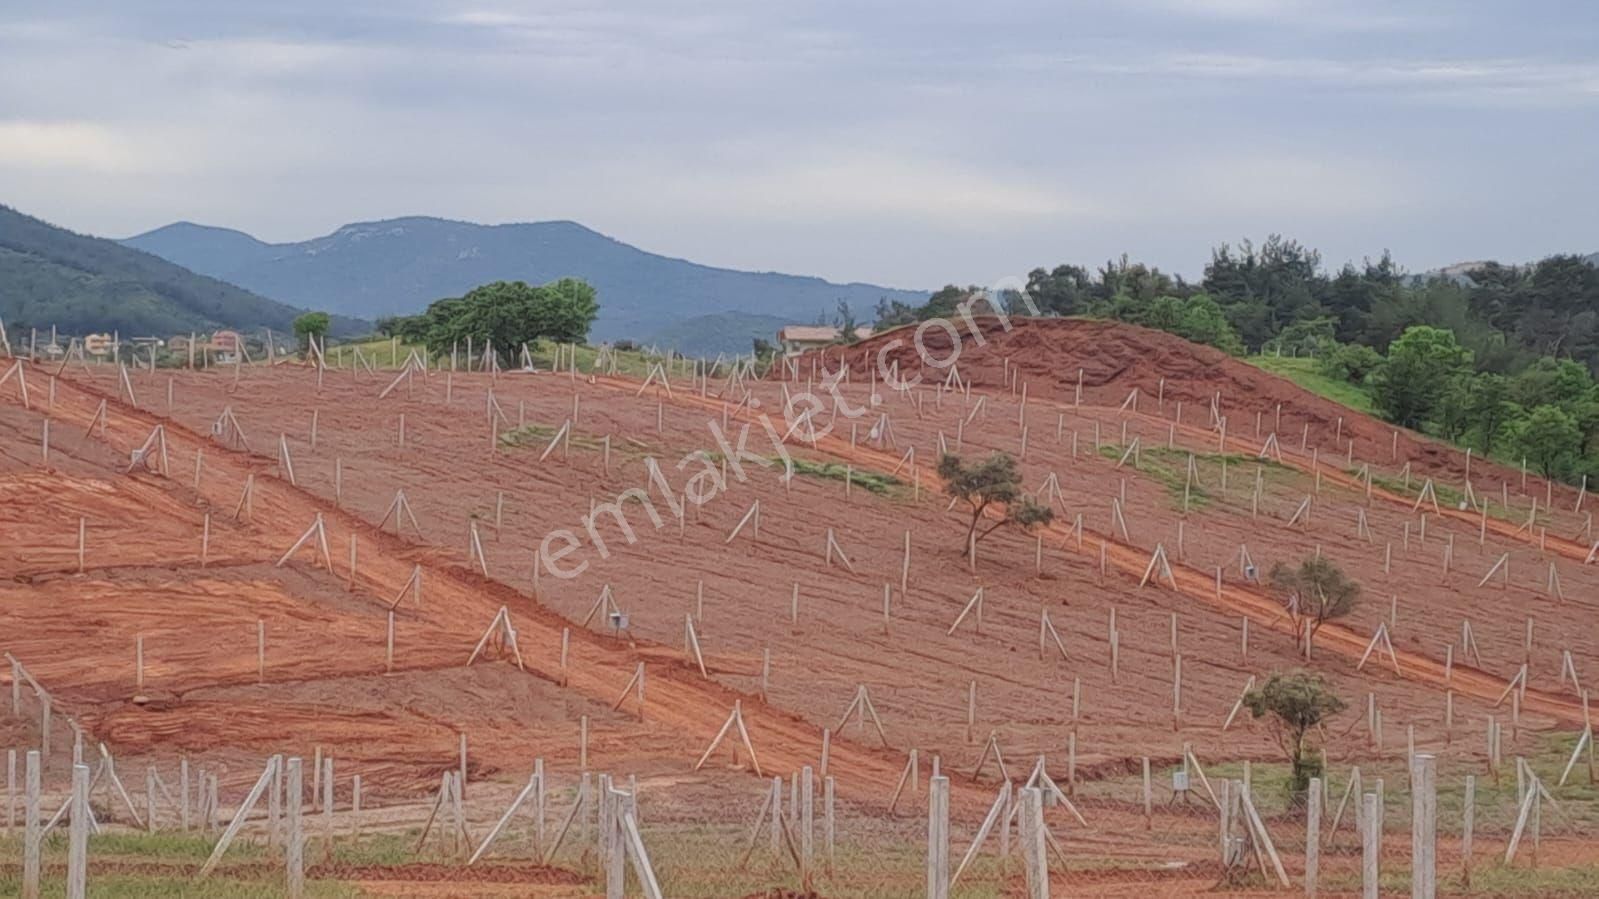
[[12, 320, 1599, 899]]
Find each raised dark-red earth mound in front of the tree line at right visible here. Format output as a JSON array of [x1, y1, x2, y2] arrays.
[[789, 317, 1483, 477]]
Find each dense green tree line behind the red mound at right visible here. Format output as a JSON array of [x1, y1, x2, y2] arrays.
[[876, 235, 1599, 480]]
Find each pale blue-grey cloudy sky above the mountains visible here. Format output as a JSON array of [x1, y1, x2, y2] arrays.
[[0, 0, 1599, 288]]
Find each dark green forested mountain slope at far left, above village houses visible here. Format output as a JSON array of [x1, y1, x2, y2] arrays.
[[0, 206, 369, 341]]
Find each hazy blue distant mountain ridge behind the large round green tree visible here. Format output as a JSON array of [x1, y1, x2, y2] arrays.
[[123, 218, 927, 352]]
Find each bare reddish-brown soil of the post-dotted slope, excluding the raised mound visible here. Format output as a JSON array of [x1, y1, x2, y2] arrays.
[[0, 342, 1599, 854]]
